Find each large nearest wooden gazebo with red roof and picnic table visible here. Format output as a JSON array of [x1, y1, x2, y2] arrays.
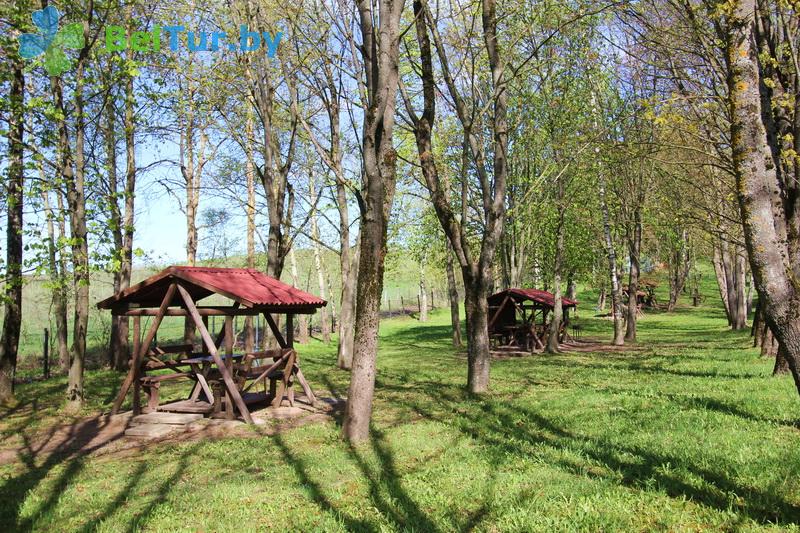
[[97, 266, 327, 423]]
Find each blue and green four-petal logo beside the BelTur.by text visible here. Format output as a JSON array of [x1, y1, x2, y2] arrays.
[[19, 6, 84, 76]]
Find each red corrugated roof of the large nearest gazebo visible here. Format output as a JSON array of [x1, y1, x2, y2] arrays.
[[97, 266, 327, 309]]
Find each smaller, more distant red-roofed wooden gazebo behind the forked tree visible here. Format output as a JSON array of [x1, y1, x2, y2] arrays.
[[487, 289, 578, 351]]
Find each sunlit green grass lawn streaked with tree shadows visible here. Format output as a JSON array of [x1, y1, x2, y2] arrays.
[[0, 282, 800, 532]]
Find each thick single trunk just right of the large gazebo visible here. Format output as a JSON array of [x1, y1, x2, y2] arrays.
[[343, 0, 403, 442]]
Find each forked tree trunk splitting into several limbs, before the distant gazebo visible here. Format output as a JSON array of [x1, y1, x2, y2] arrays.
[[401, 0, 508, 393]]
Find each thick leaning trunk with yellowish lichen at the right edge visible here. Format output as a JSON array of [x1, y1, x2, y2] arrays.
[[726, 0, 800, 393]]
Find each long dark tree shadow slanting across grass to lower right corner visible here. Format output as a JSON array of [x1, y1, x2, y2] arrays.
[[396, 384, 800, 524]]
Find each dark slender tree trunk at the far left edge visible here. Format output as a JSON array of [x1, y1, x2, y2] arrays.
[[0, 59, 25, 403]]
